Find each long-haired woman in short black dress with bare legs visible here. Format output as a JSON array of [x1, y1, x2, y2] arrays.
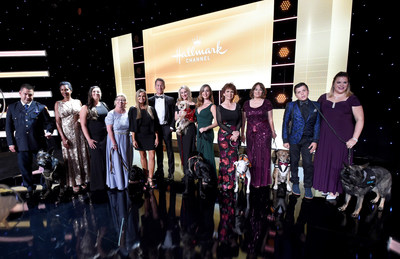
[[128, 89, 160, 188]]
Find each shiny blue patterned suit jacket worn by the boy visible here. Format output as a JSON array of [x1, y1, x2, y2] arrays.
[[282, 100, 320, 144]]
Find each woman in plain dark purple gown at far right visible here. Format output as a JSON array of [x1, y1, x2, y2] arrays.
[[314, 72, 364, 199]]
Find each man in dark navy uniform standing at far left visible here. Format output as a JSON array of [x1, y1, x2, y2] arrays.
[[6, 84, 54, 199]]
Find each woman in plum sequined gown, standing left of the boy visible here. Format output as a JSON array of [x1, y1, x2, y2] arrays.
[[241, 83, 276, 188]]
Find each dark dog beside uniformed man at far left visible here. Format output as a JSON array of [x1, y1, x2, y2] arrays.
[[36, 150, 64, 199]]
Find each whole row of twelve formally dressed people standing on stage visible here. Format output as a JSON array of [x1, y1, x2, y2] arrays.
[[6, 72, 364, 203]]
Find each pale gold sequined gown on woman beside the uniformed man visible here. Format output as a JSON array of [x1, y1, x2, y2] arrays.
[[58, 100, 89, 187]]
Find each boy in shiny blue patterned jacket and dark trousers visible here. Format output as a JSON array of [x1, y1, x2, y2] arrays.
[[282, 83, 320, 199]]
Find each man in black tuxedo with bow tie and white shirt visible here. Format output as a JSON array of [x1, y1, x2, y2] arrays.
[[149, 78, 175, 180]]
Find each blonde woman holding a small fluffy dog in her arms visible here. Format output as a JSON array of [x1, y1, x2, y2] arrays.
[[175, 85, 196, 176]]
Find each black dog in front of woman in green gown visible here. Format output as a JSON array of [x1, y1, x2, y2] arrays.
[[185, 154, 212, 199]]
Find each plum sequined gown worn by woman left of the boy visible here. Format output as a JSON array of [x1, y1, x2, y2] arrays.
[[243, 99, 272, 187]]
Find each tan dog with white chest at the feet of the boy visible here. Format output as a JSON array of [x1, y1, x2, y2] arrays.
[[273, 149, 292, 192]]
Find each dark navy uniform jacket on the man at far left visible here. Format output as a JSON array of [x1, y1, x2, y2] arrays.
[[6, 101, 54, 151]]
